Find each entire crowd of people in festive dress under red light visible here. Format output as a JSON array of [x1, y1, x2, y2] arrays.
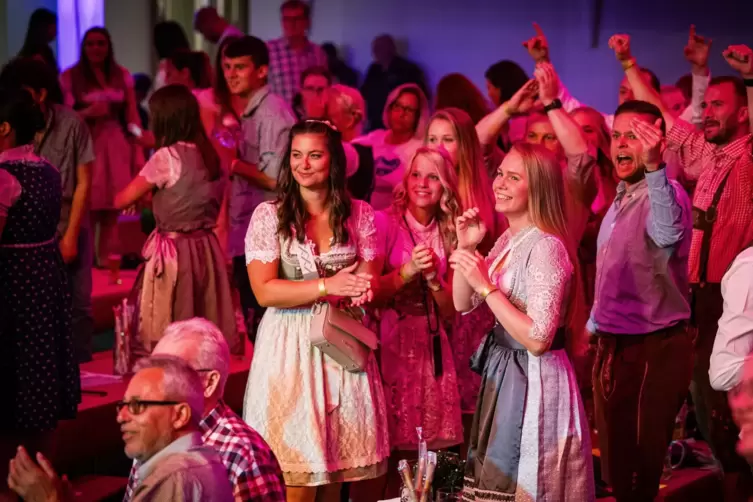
[[0, 0, 753, 502]]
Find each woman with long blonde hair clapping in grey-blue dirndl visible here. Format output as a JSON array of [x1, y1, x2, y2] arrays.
[[450, 143, 594, 502]]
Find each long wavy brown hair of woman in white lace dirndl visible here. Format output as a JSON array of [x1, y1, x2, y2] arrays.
[[277, 120, 353, 244]]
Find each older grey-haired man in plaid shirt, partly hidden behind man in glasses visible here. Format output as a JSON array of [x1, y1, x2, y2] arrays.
[[125, 317, 285, 502]]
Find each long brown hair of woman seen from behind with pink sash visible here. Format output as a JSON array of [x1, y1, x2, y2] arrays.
[[149, 84, 221, 181]]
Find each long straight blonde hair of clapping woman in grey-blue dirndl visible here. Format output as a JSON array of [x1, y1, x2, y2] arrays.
[[511, 142, 585, 346]]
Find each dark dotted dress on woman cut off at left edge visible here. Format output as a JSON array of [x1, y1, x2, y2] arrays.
[[0, 148, 81, 433]]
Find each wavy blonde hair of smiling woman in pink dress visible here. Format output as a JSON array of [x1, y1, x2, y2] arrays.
[[391, 146, 461, 255]]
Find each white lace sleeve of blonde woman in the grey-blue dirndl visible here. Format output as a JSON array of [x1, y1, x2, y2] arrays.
[[526, 236, 573, 342]]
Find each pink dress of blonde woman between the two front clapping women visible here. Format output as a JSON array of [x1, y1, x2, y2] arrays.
[[377, 212, 463, 450]]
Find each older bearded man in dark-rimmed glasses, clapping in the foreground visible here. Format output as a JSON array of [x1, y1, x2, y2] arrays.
[[8, 355, 233, 502]]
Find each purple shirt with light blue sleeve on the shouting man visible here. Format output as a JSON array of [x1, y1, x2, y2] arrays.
[[589, 169, 692, 334]]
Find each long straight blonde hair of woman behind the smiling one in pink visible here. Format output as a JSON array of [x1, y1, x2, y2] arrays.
[[424, 108, 498, 242]]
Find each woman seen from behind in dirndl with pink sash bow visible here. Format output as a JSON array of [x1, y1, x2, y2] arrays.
[[115, 85, 238, 355]]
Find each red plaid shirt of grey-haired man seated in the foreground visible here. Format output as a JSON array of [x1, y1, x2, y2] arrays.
[[123, 401, 286, 502]]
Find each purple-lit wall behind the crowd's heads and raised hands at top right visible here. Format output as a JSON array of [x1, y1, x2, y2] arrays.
[[250, 0, 753, 111]]
